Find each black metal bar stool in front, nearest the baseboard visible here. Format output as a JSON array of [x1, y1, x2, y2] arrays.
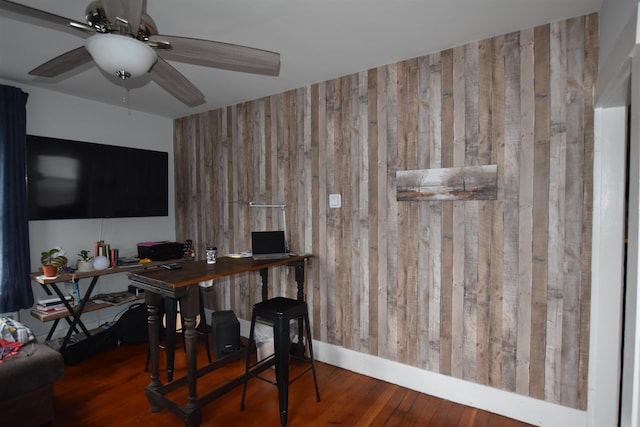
[[240, 297, 320, 427]]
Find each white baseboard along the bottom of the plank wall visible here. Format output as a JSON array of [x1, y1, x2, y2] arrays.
[[239, 319, 587, 427]]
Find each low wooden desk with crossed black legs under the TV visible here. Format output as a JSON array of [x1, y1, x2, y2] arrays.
[[30, 260, 182, 352]]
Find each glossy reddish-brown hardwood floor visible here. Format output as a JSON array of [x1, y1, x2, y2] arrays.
[[53, 344, 529, 427]]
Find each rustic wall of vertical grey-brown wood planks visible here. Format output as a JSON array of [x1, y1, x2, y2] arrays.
[[175, 15, 598, 409]]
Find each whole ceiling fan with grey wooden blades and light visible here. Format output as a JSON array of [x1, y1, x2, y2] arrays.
[[0, 0, 280, 107]]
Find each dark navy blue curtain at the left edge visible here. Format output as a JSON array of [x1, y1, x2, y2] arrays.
[[0, 85, 33, 313]]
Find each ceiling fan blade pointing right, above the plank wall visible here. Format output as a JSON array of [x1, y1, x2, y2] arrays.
[[149, 35, 280, 76]]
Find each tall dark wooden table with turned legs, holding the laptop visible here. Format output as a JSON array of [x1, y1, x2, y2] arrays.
[[129, 255, 311, 427]]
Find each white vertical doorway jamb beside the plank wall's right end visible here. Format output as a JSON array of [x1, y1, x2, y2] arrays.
[[587, 106, 626, 427]]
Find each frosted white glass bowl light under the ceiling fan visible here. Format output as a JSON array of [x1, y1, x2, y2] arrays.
[[85, 34, 158, 80]]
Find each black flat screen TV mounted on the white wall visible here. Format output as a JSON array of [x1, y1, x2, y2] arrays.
[[27, 135, 169, 220]]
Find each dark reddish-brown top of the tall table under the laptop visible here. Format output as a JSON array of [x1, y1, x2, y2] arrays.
[[129, 255, 311, 289]]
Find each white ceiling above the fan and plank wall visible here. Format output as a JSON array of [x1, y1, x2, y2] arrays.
[[0, 0, 602, 118]]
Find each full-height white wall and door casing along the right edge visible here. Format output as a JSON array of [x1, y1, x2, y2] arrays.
[[588, 0, 640, 426]]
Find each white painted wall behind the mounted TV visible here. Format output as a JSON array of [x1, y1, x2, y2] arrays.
[[0, 80, 175, 340]]
